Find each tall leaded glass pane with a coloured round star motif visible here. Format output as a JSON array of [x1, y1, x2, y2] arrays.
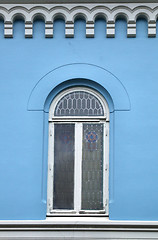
[[82, 124, 103, 210]]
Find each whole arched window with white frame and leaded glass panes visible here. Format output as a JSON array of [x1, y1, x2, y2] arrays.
[[47, 87, 109, 215]]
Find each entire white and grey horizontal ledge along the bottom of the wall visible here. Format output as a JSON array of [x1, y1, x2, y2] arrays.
[[0, 217, 158, 240]]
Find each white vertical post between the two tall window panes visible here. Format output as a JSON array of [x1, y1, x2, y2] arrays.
[[74, 123, 82, 213]]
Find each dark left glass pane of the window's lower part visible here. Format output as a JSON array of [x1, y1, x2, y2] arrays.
[[53, 124, 74, 209]]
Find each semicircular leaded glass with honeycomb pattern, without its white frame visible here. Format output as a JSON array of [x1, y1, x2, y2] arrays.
[[54, 91, 104, 116]]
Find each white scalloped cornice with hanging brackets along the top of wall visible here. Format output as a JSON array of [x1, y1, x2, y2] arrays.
[[0, 0, 158, 37]]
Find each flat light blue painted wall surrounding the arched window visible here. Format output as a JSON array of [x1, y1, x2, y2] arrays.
[[0, 19, 158, 220]]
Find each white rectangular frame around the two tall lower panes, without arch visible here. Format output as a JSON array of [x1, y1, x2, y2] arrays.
[[47, 121, 109, 216]]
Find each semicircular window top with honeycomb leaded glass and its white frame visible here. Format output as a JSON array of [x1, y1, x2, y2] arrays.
[[50, 87, 108, 118]]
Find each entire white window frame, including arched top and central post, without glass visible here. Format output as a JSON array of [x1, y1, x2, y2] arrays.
[[47, 87, 109, 216]]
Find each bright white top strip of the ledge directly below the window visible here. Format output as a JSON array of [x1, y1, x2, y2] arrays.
[[0, 216, 158, 225]]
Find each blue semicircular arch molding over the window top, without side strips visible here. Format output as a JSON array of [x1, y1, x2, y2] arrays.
[[28, 63, 131, 112]]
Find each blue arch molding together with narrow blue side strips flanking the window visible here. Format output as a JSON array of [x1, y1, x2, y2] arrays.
[[27, 63, 130, 214]]
